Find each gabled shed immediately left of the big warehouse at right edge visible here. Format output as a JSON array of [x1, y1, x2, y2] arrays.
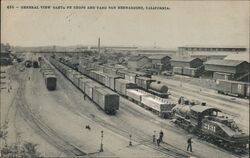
[[170, 57, 203, 68]]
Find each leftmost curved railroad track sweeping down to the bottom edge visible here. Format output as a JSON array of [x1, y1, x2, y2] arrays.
[[15, 67, 90, 157]]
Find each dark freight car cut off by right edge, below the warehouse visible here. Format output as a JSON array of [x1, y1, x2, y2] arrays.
[[216, 80, 249, 98]]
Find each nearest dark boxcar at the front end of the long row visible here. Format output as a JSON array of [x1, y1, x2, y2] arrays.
[[93, 87, 119, 114]]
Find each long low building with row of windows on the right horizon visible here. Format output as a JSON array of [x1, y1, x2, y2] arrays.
[[177, 46, 247, 61]]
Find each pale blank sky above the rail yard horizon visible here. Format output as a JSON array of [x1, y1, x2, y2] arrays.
[[1, 0, 249, 48]]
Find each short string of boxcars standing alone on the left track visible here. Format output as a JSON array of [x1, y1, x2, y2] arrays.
[[40, 60, 57, 90]]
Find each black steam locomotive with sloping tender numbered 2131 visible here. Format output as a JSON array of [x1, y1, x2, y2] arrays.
[[172, 104, 249, 152]]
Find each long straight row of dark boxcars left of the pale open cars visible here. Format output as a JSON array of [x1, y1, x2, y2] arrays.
[[50, 58, 119, 114]]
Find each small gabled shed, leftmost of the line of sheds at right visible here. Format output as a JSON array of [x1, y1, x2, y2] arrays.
[[128, 55, 151, 70]]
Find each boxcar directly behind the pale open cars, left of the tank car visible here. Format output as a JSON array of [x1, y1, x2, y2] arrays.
[[115, 79, 136, 95]]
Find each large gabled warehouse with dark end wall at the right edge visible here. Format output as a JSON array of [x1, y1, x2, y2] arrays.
[[205, 60, 249, 81]]
